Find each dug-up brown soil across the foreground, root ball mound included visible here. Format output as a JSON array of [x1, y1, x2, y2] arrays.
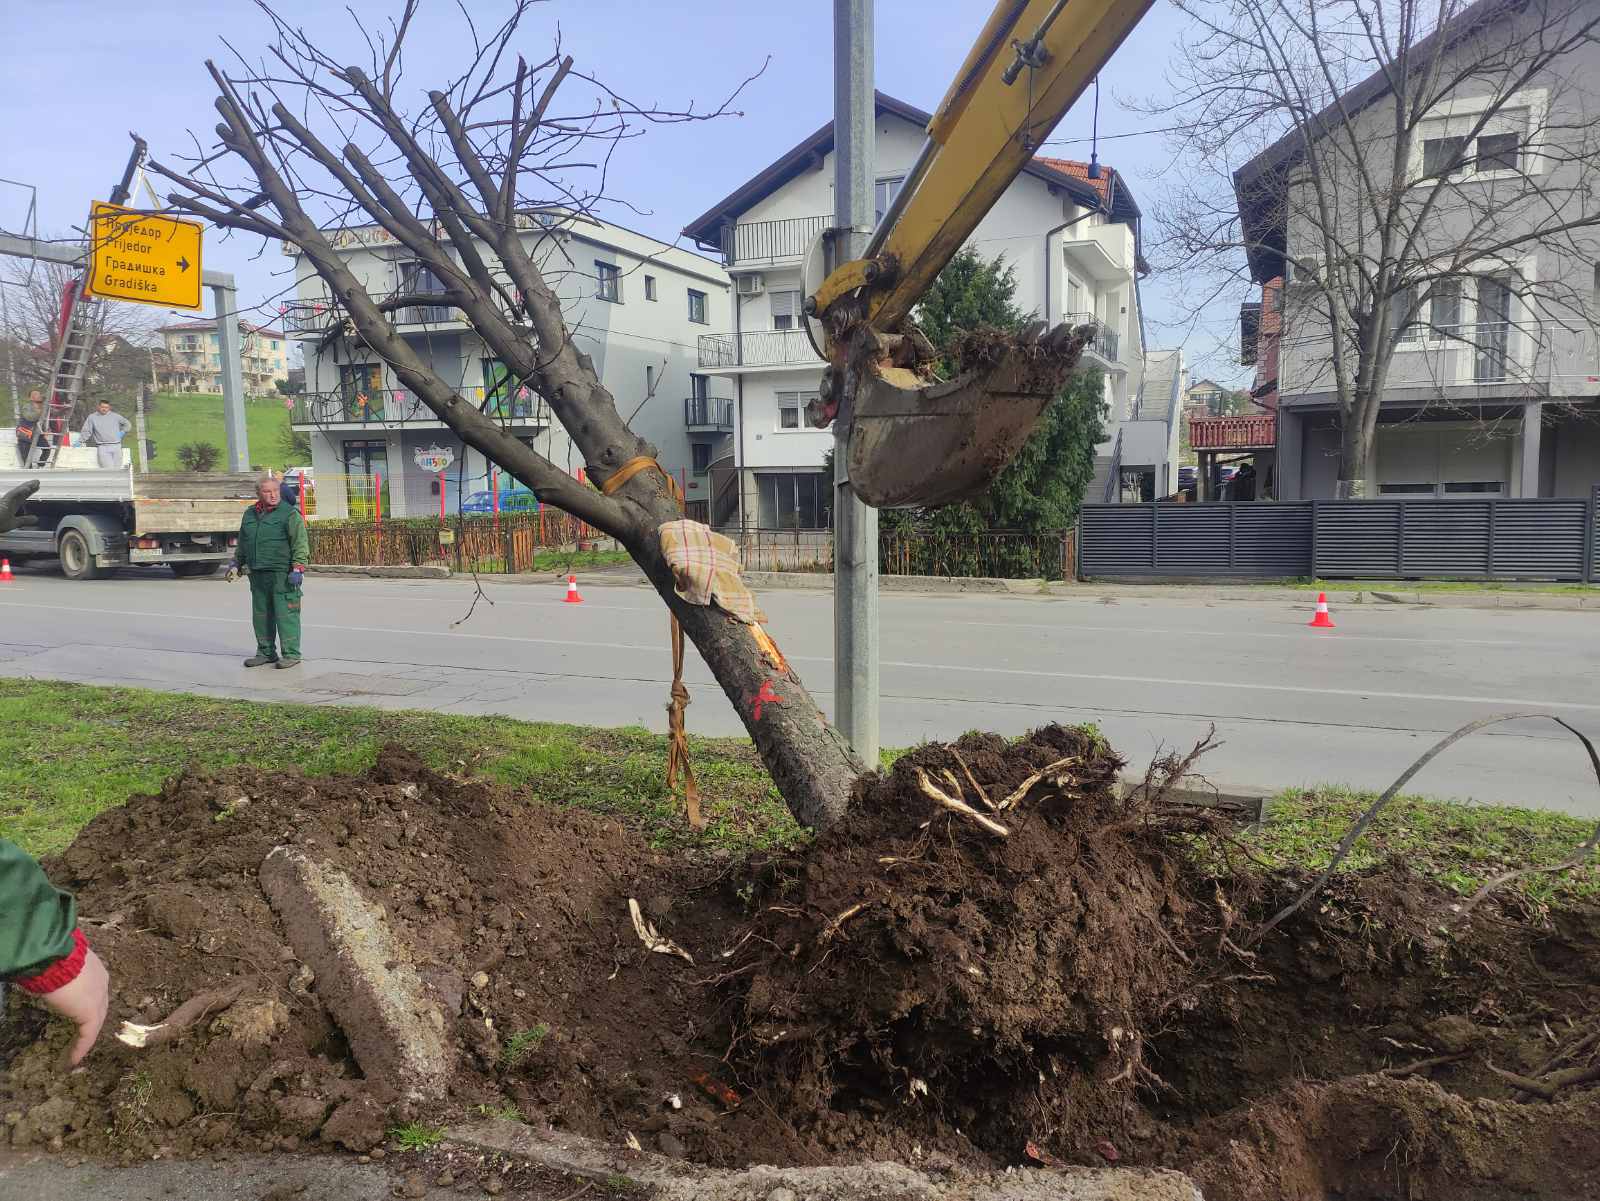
[[0, 726, 1600, 1201]]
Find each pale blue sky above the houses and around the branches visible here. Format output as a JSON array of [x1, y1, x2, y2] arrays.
[[0, 0, 1243, 379]]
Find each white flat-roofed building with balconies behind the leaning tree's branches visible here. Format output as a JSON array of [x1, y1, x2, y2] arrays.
[[283, 211, 733, 517]]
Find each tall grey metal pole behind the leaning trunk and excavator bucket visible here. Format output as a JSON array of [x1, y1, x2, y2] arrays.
[[834, 0, 878, 769]]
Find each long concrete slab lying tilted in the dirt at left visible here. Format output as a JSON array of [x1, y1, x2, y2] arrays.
[[259, 846, 454, 1099]]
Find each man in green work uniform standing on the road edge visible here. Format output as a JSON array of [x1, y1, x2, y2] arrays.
[[227, 475, 310, 668]]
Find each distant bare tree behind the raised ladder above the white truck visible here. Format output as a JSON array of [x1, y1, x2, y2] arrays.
[[0, 261, 160, 418]]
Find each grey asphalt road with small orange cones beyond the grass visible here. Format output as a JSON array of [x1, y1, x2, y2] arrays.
[[0, 568, 1600, 816]]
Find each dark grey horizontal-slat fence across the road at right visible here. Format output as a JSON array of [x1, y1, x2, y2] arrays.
[[1078, 488, 1600, 584]]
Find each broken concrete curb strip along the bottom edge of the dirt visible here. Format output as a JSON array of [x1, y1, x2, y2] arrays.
[[446, 1121, 1205, 1201]]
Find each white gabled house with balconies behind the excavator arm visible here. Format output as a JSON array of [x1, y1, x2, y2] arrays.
[[683, 93, 1178, 529]]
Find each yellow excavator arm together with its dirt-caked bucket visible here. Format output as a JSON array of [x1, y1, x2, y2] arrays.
[[805, 0, 1150, 507]]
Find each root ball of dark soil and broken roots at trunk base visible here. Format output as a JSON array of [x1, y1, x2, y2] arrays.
[[728, 726, 1216, 1159]]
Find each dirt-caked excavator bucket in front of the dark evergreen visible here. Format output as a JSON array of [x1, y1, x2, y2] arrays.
[[848, 326, 1086, 509]]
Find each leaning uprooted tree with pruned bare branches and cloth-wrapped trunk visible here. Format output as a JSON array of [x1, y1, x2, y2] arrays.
[[150, 0, 862, 827]]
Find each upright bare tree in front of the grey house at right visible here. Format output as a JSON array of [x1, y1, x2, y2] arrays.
[[1142, 0, 1600, 496]]
